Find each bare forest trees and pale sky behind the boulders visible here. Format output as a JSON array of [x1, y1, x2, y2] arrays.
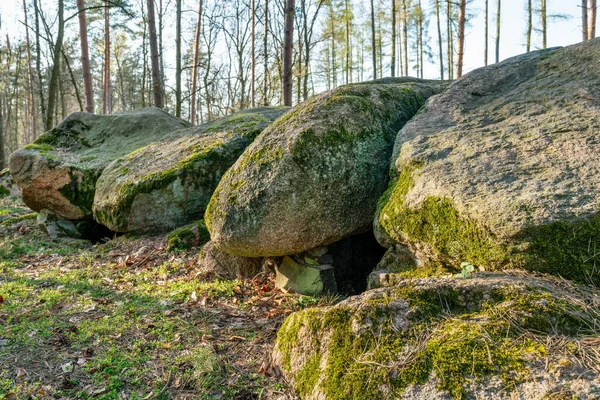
[[0, 0, 597, 169]]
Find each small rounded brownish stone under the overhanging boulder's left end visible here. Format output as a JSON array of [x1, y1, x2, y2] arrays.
[[198, 242, 262, 279]]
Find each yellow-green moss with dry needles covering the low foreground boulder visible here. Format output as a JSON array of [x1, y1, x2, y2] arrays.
[[276, 280, 599, 400]]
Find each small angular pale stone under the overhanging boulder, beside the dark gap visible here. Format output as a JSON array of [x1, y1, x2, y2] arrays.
[[275, 256, 337, 296]]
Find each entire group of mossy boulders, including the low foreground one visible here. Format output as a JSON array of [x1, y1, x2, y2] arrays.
[[10, 40, 600, 399]]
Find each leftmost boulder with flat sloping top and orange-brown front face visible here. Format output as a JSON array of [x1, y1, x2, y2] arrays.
[[9, 108, 190, 220]]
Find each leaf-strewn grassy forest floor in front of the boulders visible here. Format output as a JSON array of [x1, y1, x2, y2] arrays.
[[0, 198, 335, 400]]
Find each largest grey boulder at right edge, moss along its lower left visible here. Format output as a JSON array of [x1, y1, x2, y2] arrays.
[[375, 40, 600, 284]]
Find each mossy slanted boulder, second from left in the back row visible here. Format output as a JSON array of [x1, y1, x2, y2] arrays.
[[94, 107, 289, 232]]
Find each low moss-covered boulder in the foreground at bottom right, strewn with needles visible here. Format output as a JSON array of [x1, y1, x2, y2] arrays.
[[273, 273, 600, 400]]
